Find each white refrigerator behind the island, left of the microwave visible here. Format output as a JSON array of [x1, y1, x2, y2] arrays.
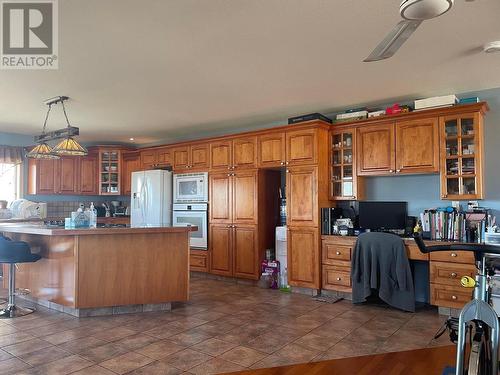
[[130, 169, 172, 227]]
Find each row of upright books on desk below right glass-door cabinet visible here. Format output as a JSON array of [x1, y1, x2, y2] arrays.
[[420, 209, 466, 241]]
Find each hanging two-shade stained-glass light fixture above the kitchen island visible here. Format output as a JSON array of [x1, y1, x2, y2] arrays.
[[26, 96, 88, 159]]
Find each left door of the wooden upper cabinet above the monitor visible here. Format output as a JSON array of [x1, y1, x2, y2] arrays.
[[356, 122, 396, 176]]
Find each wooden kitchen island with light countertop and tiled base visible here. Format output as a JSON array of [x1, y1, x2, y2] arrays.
[[0, 223, 197, 316]]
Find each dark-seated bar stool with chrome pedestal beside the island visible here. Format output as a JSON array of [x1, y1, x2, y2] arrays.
[[0, 236, 41, 319]]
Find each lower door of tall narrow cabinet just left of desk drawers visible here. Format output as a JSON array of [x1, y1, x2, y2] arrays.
[[287, 227, 320, 289]]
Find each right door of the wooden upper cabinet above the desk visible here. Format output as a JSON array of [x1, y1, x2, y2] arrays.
[[396, 117, 439, 173]]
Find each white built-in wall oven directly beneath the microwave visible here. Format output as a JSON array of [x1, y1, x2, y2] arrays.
[[173, 203, 208, 250]]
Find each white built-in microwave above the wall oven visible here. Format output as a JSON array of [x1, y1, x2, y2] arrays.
[[174, 172, 208, 203]]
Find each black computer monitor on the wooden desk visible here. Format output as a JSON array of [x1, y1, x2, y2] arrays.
[[358, 201, 408, 230]]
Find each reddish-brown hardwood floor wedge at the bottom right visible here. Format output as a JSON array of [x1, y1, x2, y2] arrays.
[[228, 345, 456, 375]]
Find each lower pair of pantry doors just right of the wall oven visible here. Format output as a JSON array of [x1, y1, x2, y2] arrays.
[[210, 224, 259, 280]]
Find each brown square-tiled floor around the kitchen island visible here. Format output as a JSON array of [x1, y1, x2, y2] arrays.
[[0, 278, 449, 375]]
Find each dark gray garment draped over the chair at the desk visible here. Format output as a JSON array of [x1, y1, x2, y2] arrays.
[[351, 233, 415, 311]]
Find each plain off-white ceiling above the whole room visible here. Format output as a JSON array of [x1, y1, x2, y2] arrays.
[[0, 0, 500, 144]]
